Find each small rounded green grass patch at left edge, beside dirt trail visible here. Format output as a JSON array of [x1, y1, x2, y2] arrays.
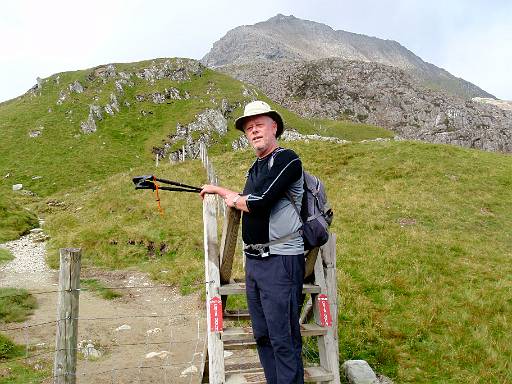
[[0, 288, 37, 323]]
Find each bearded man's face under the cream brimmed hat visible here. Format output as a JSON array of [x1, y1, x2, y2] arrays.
[[243, 115, 277, 157]]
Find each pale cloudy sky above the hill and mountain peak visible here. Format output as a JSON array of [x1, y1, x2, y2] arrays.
[[0, 0, 512, 101]]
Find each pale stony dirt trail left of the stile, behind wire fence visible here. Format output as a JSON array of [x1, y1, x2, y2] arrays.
[[0, 234, 206, 384]]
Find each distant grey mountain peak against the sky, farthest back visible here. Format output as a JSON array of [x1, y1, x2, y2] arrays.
[[201, 14, 495, 99]]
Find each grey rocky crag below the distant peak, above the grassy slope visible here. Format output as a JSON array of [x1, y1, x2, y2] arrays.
[[223, 59, 512, 152]]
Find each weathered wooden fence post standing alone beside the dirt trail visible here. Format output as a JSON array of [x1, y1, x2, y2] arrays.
[[53, 248, 82, 384]]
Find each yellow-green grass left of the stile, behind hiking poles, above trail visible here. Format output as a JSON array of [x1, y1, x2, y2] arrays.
[[40, 161, 205, 292]]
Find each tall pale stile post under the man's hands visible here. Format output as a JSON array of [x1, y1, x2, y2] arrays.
[[203, 195, 226, 384]]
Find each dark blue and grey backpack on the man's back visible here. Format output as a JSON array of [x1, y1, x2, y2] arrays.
[[286, 171, 334, 251]]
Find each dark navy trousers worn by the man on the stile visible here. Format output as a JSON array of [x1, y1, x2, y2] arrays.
[[245, 254, 304, 384]]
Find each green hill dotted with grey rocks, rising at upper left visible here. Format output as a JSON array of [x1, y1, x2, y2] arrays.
[[0, 59, 390, 200]]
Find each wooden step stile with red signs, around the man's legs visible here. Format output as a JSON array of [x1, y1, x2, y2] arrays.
[[201, 187, 340, 384]]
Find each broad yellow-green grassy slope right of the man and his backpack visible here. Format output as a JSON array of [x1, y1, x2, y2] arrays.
[[210, 142, 512, 383]]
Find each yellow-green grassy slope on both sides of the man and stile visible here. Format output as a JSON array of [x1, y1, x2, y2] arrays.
[[42, 142, 512, 383]]
